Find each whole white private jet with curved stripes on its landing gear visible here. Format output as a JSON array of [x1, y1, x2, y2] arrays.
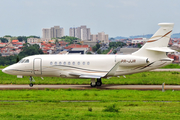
[[2, 23, 175, 87]]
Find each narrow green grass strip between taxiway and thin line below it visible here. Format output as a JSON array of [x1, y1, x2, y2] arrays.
[[0, 89, 180, 102]]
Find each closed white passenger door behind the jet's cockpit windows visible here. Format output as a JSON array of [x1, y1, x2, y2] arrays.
[[33, 58, 42, 75]]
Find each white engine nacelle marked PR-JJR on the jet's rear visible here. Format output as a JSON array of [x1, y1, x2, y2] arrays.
[[119, 56, 149, 67]]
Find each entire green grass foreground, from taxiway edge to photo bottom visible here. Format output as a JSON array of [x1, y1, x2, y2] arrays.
[[0, 89, 180, 120]]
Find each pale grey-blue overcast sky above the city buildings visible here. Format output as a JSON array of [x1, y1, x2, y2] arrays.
[[0, 0, 180, 37]]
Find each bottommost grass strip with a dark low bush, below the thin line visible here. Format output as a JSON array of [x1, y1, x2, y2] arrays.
[[0, 102, 180, 120]]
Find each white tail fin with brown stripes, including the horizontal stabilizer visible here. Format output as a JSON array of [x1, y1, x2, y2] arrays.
[[132, 23, 175, 59]]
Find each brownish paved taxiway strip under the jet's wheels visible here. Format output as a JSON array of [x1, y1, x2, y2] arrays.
[[0, 85, 180, 90]]
